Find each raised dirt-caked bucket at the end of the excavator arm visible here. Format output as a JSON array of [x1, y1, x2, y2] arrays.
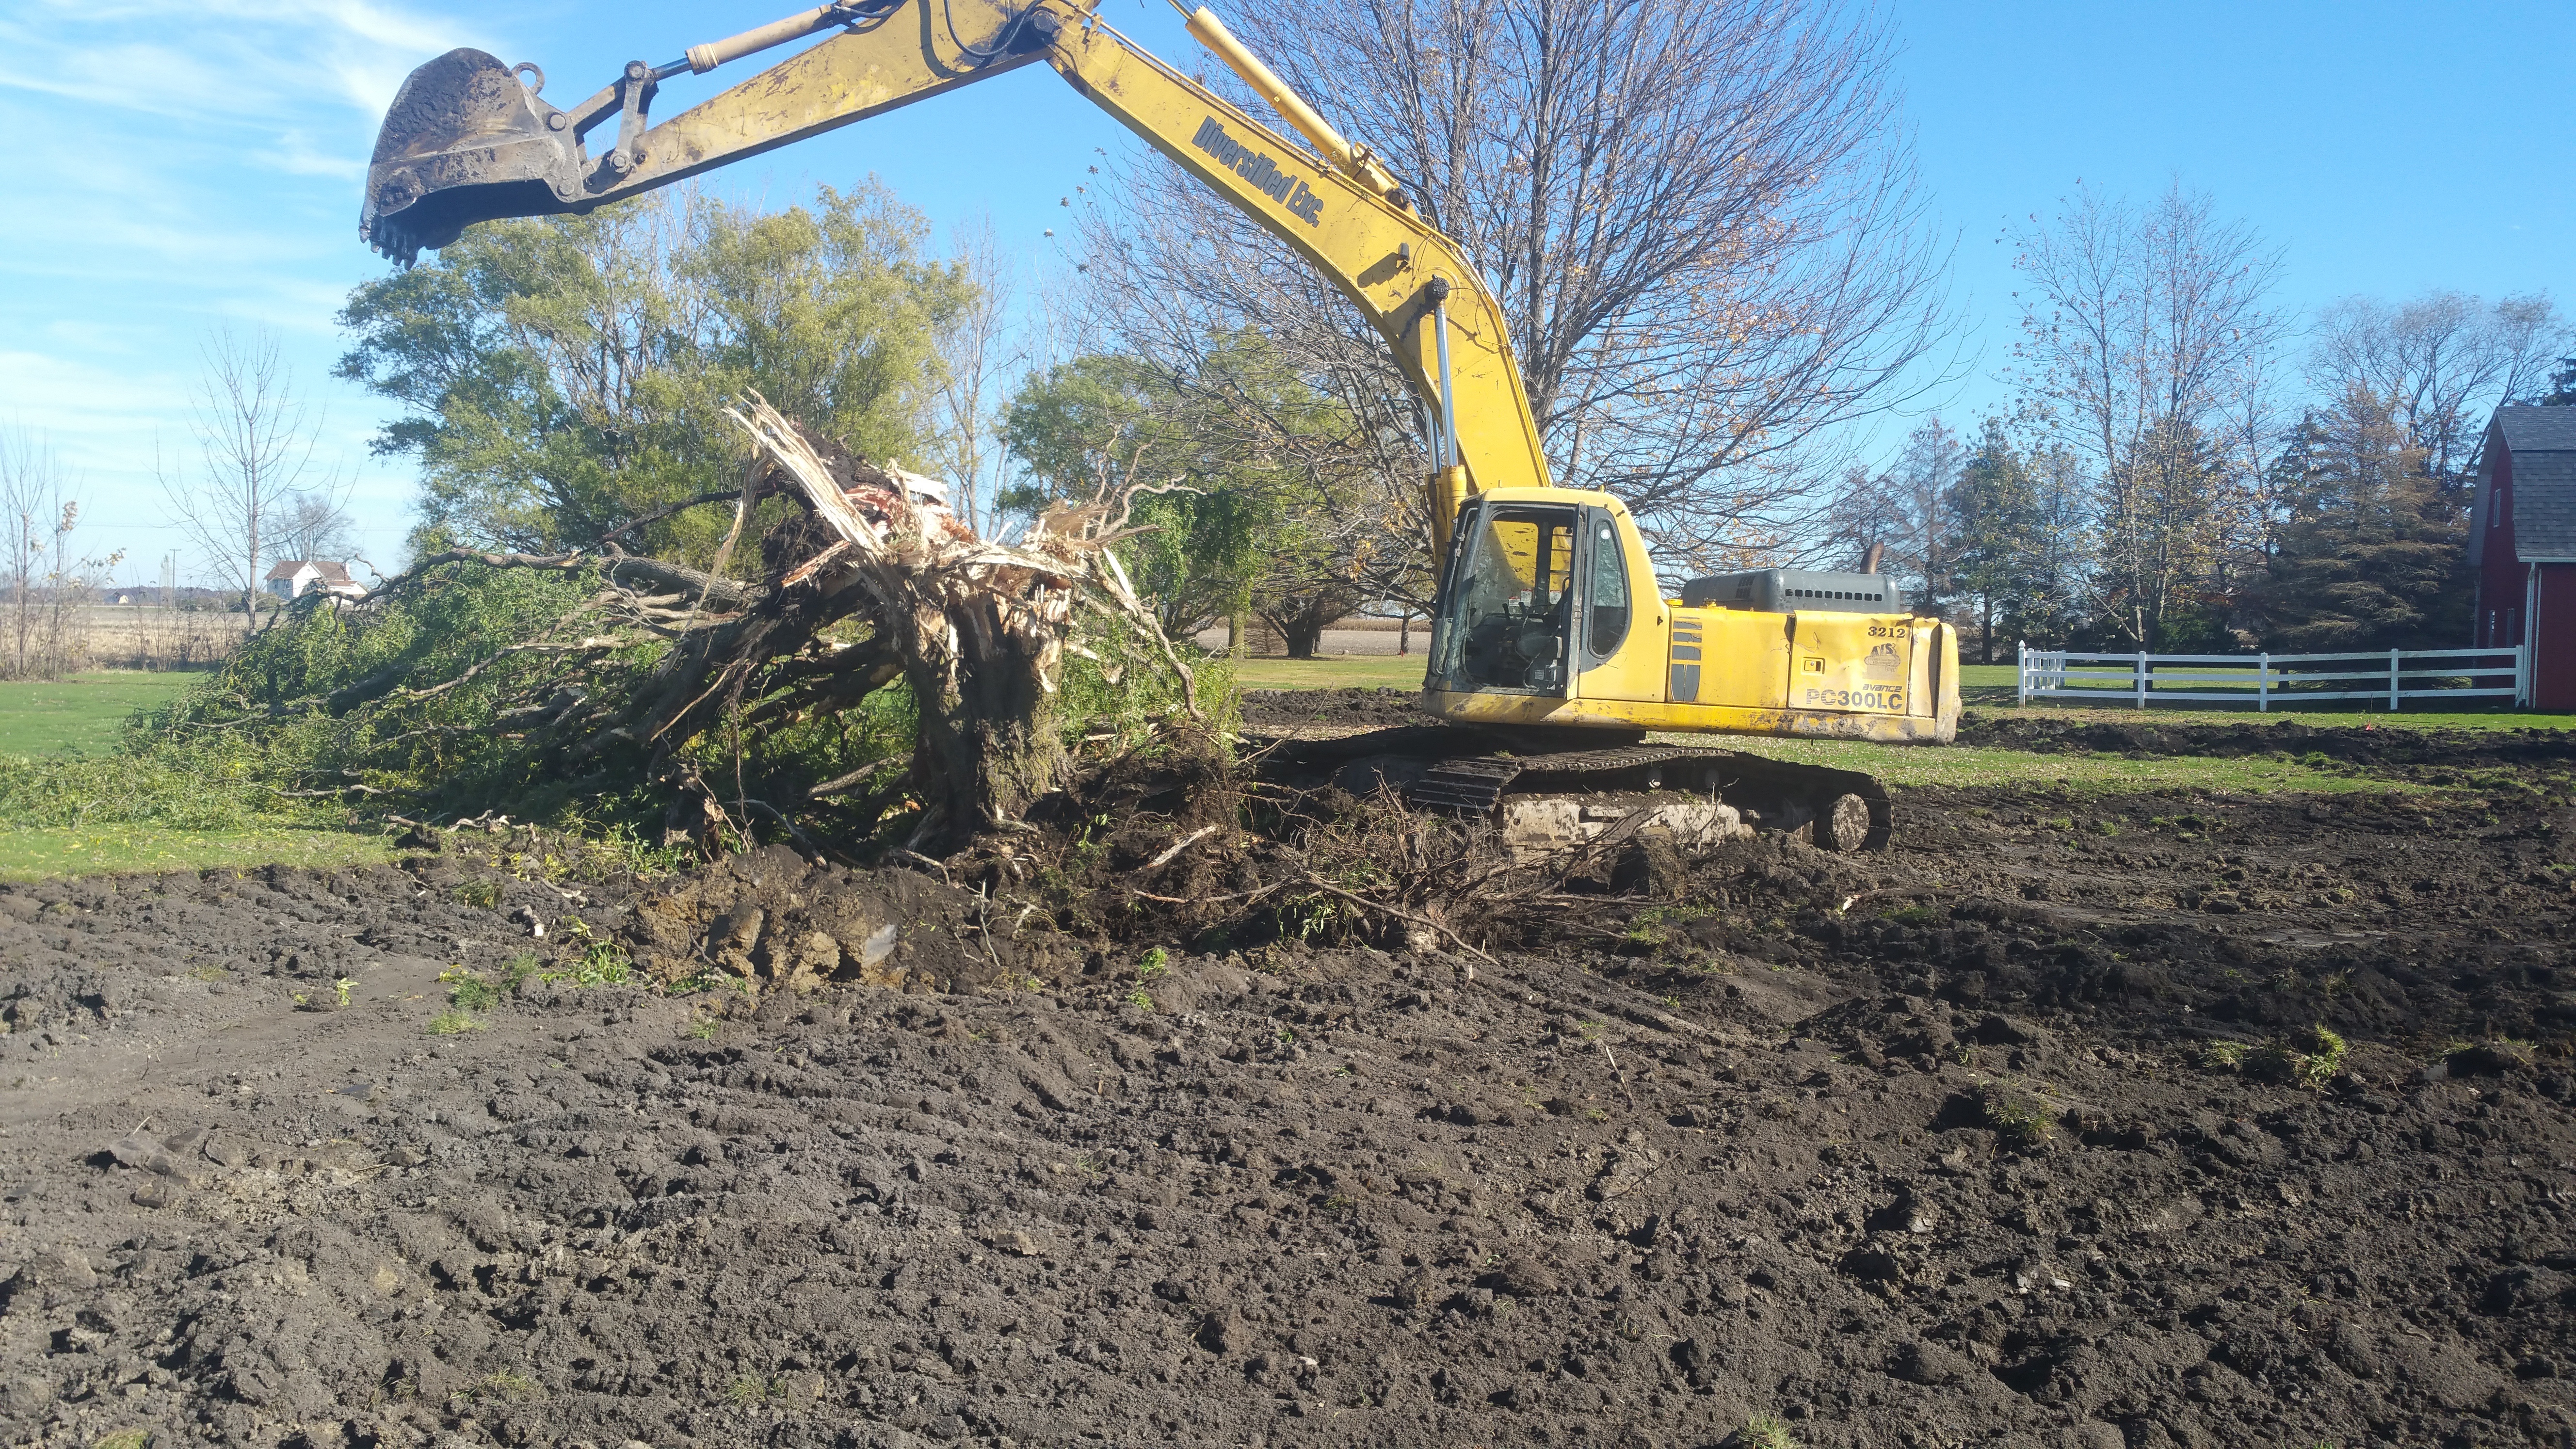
[[358, 49, 580, 266]]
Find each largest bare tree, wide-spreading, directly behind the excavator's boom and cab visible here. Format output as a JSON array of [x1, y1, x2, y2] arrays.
[[1082, 0, 1948, 564]]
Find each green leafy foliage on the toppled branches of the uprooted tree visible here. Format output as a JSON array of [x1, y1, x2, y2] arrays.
[[116, 562, 927, 840]]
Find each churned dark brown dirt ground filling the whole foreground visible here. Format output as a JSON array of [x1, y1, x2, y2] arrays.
[[0, 704, 2576, 1449]]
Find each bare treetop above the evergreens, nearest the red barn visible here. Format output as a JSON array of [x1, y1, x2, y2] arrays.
[[2308, 291, 2568, 492]]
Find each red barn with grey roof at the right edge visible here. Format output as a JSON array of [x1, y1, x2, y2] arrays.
[[2468, 407, 2576, 709]]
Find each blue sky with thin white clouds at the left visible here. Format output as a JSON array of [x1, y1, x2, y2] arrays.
[[0, 0, 2576, 580]]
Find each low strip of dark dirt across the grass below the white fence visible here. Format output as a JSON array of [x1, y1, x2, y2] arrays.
[[1958, 711, 2576, 766]]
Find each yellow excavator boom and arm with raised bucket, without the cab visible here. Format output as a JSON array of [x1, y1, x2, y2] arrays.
[[361, 0, 1548, 554]]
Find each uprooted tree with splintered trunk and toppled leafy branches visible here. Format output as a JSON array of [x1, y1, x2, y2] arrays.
[[162, 397, 1200, 853]]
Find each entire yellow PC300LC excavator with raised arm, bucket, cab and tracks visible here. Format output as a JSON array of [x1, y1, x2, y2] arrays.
[[358, 0, 1958, 851]]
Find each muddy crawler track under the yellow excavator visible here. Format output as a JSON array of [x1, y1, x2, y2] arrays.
[[1268, 724, 1896, 851]]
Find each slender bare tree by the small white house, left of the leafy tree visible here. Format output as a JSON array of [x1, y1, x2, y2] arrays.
[[160, 327, 320, 637]]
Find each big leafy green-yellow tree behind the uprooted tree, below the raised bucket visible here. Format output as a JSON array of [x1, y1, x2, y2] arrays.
[[338, 183, 974, 562]]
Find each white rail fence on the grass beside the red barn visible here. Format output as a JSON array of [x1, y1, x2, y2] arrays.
[[2020, 644, 2532, 709]]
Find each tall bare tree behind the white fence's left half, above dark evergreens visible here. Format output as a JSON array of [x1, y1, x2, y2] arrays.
[[2014, 183, 2285, 650]]
